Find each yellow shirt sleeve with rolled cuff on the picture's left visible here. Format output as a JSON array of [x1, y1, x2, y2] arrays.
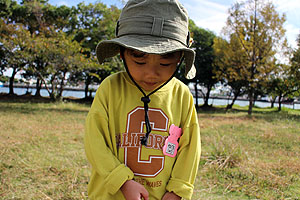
[[84, 86, 133, 194]]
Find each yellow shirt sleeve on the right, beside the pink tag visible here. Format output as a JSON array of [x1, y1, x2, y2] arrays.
[[166, 93, 201, 199]]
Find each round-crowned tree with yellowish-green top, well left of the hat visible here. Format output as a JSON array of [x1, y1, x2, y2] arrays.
[[29, 31, 86, 101]]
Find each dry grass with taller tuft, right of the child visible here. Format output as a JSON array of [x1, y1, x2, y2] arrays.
[[194, 109, 300, 200]]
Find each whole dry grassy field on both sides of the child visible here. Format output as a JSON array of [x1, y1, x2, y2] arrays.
[[0, 102, 300, 200]]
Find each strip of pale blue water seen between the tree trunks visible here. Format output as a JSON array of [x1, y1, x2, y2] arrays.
[[0, 87, 300, 109]]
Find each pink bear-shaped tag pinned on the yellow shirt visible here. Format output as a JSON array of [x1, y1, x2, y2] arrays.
[[163, 124, 181, 157]]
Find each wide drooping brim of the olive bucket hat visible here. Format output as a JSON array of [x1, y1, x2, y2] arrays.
[[96, 35, 196, 79]]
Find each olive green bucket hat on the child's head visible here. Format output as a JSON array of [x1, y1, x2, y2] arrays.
[[96, 0, 196, 79]]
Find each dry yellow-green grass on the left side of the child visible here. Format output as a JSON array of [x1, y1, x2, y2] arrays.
[[0, 103, 89, 199]]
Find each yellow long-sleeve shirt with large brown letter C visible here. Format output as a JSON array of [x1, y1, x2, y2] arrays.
[[85, 72, 201, 200]]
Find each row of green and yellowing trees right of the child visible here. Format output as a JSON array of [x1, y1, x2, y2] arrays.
[[193, 0, 300, 114]]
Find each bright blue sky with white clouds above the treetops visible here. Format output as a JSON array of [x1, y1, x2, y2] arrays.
[[49, 0, 300, 48]]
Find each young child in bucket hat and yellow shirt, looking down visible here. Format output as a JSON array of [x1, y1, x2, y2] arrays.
[[85, 0, 201, 200]]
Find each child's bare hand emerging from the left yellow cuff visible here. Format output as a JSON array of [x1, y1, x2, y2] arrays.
[[121, 180, 149, 200]]
